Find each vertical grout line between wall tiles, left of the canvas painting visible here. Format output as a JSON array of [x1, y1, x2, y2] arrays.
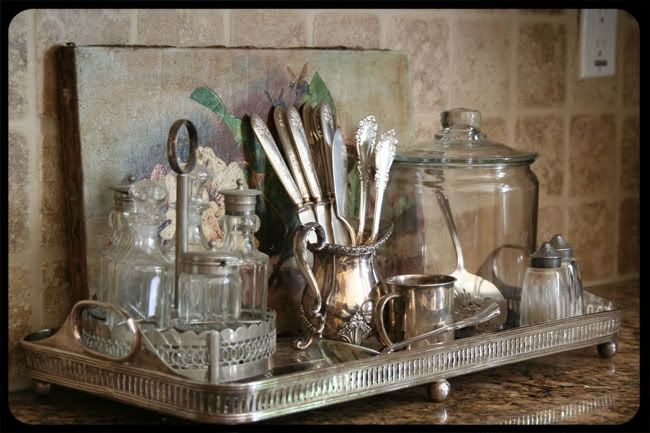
[[26, 11, 43, 330]]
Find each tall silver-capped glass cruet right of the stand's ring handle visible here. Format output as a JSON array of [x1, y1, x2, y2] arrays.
[[219, 179, 269, 320]]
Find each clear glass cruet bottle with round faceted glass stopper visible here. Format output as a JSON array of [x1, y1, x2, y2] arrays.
[[113, 179, 173, 327]]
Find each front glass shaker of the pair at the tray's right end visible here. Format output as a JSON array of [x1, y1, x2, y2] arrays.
[[519, 242, 570, 326]]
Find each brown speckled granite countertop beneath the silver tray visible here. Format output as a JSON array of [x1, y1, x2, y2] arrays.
[[9, 280, 640, 424]]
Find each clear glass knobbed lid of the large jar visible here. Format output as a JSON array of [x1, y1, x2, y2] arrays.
[[395, 108, 537, 165]]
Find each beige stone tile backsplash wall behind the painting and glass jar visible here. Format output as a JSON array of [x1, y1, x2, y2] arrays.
[[8, 9, 640, 389]]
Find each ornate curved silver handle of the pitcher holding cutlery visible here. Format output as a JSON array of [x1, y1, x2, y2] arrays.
[[293, 222, 325, 350]]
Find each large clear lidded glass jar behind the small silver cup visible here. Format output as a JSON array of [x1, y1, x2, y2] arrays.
[[380, 108, 539, 323]]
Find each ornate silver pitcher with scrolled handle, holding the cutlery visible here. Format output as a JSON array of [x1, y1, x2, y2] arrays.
[[293, 221, 393, 349]]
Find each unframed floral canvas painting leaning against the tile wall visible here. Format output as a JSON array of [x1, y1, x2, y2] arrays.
[[58, 44, 414, 331]]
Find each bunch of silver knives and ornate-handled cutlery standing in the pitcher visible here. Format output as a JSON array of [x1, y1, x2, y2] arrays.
[[251, 103, 398, 246]]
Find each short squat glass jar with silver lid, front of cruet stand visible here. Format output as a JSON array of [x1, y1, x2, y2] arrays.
[[175, 249, 242, 332]]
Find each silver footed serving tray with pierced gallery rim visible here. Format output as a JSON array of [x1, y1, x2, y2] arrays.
[[21, 292, 621, 424]]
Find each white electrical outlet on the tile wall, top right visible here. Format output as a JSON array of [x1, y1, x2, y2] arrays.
[[580, 9, 618, 78]]
